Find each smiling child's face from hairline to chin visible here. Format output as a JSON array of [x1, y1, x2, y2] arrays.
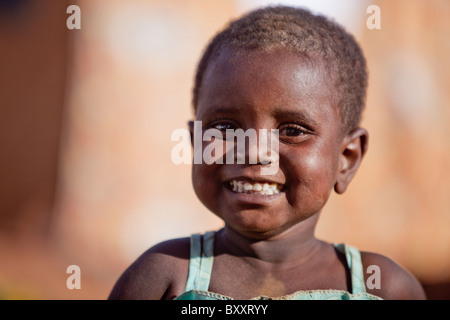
[[192, 47, 343, 238]]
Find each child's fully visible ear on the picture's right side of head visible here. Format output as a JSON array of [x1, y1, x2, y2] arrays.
[[334, 128, 369, 194]]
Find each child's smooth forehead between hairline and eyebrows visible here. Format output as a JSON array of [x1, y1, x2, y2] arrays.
[[196, 50, 337, 124]]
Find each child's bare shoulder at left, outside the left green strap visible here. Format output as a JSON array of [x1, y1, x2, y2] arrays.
[[108, 238, 190, 300]]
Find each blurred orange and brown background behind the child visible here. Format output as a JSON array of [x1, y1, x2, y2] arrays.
[[0, 0, 450, 299]]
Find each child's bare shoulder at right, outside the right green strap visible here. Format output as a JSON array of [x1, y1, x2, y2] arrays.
[[361, 252, 426, 300]]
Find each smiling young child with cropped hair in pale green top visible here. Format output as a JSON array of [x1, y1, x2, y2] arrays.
[[109, 7, 425, 300]]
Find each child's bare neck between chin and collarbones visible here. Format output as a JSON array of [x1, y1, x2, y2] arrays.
[[218, 214, 322, 266]]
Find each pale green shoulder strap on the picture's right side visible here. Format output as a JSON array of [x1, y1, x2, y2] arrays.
[[335, 243, 366, 294]]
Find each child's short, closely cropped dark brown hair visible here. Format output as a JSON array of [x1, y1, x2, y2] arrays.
[[193, 6, 368, 132]]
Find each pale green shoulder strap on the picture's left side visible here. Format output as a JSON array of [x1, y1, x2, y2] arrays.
[[186, 231, 215, 291]]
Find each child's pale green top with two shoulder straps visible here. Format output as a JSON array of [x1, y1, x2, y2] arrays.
[[175, 231, 382, 300]]
